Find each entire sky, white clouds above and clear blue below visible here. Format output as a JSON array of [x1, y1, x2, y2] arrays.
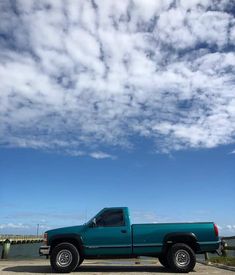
[[0, 0, 235, 235]]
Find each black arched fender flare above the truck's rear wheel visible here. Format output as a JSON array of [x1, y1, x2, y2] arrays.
[[163, 235, 199, 253]]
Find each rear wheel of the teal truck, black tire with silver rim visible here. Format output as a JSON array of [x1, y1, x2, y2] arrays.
[[167, 243, 196, 273]]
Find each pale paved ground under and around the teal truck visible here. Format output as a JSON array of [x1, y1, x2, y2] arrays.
[[0, 260, 235, 275]]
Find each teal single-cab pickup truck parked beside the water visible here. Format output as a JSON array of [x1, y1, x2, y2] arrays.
[[39, 207, 220, 273]]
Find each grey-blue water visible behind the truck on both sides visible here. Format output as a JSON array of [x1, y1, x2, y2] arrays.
[[0, 239, 235, 260]]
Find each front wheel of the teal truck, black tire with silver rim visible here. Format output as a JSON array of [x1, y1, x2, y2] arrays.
[[50, 243, 80, 273]]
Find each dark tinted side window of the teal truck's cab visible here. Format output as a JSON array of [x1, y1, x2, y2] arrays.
[[96, 209, 125, 227]]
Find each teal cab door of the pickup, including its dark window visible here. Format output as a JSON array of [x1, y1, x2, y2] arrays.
[[83, 209, 132, 256]]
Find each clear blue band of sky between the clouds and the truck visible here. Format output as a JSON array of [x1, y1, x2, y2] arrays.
[[0, 143, 235, 235]]
